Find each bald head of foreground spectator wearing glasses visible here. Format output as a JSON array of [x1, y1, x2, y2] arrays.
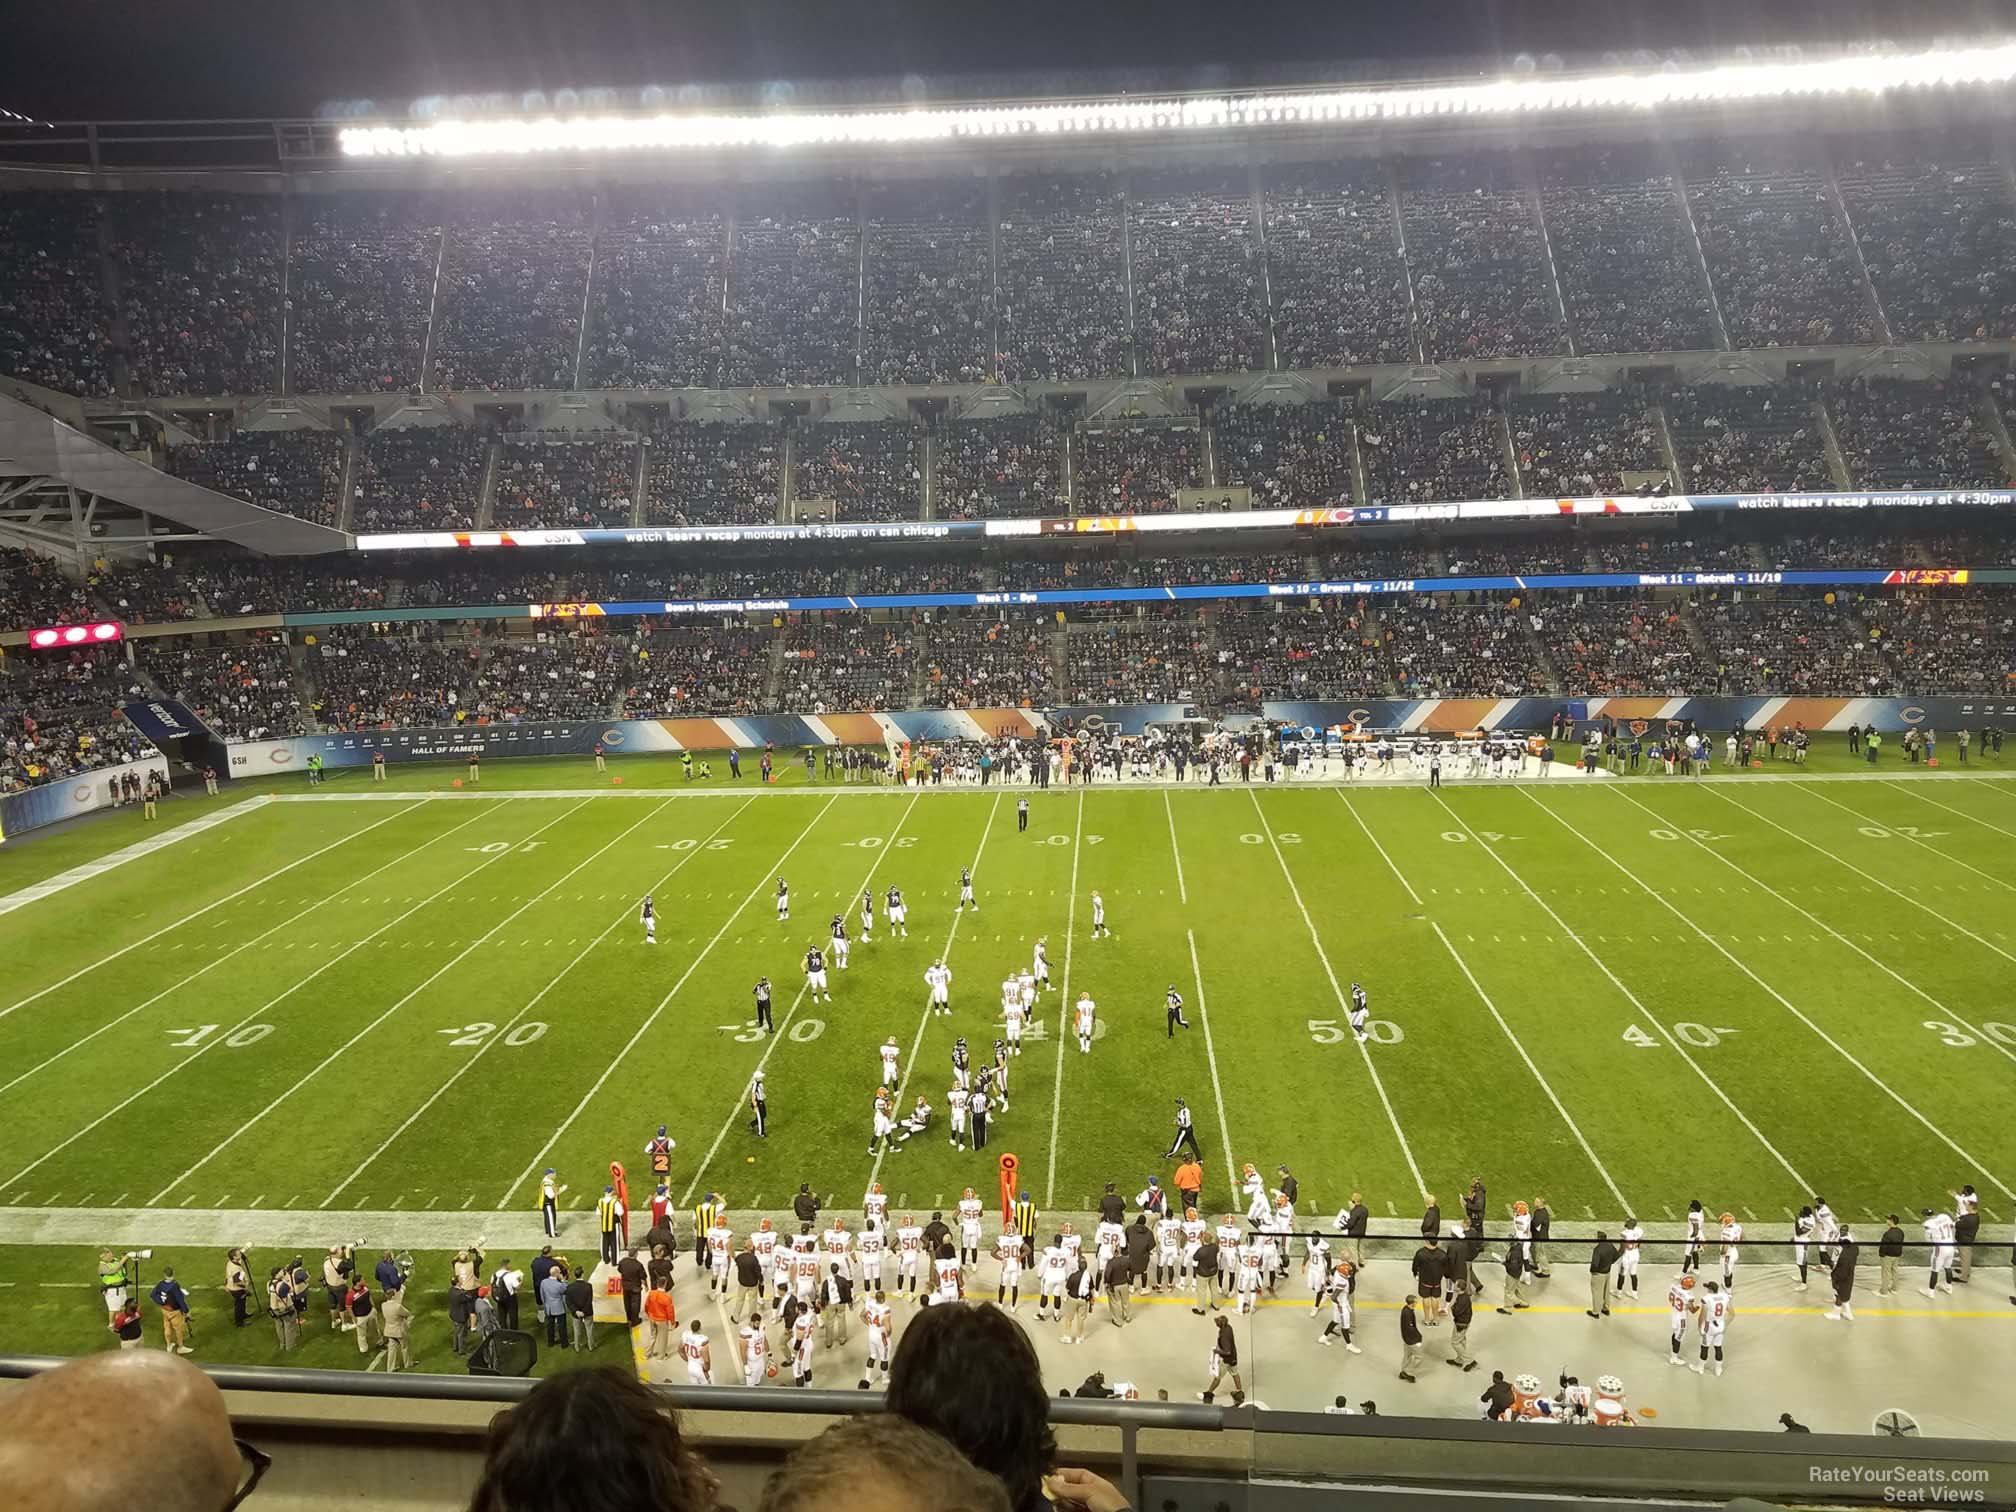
[[0, 1349, 252, 1512]]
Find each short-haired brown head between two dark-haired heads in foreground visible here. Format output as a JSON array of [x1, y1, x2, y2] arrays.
[[760, 1419, 1010, 1512]]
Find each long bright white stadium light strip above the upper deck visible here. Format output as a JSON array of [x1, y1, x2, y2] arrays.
[[339, 42, 2016, 157]]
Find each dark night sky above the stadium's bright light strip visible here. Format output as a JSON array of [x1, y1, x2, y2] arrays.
[[0, 0, 2016, 121]]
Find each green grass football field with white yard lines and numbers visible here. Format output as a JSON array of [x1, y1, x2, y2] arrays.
[[0, 762, 2016, 1232]]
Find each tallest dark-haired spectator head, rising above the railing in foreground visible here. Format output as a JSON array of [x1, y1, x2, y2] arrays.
[[889, 1302, 1056, 1512]]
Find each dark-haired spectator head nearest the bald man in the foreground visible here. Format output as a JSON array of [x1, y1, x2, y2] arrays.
[[470, 1367, 720, 1512]]
